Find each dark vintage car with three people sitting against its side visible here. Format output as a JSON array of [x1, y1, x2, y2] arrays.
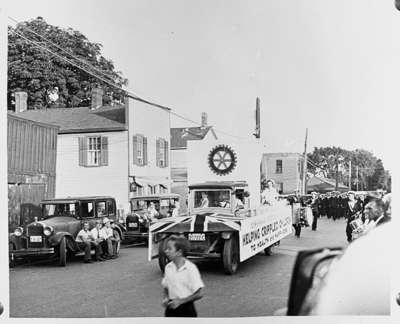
[[9, 196, 124, 267]]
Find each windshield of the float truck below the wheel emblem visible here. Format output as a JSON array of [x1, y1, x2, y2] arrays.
[[194, 189, 231, 208]]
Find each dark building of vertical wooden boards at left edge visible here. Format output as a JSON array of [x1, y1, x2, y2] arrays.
[[7, 112, 59, 230]]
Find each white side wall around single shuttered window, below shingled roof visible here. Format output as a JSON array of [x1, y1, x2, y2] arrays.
[[56, 131, 129, 211]]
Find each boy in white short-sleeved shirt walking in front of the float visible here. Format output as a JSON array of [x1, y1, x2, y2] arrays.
[[161, 235, 204, 317]]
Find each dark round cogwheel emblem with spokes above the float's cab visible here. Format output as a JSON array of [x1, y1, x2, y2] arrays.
[[208, 145, 237, 175]]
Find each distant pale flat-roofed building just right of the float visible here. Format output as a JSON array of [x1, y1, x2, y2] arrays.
[[261, 153, 303, 194]]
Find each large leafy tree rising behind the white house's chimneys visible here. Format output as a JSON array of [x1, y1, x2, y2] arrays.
[[8, 17, 127, 109]]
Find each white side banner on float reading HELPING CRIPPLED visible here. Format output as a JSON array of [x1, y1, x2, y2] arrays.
[[239, 207, 292, 262]]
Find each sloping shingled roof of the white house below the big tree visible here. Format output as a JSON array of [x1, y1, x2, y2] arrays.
[[12, 106, 126, 134]]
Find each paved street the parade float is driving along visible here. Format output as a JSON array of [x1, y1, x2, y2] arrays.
[[10, 218, 347, 317]]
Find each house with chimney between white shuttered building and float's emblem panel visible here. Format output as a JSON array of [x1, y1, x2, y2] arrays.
[[171, 113, 217, 211]]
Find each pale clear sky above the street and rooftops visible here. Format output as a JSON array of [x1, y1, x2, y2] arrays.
[[0, 0, 400, 170]]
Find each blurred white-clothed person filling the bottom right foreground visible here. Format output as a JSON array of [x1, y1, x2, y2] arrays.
[[310, 224, 394, 316]]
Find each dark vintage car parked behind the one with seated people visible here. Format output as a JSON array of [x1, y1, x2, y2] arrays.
[[124, 194, 180, 242]]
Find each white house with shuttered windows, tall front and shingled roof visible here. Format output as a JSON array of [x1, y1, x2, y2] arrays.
[[10, 89, 170, 212]]
